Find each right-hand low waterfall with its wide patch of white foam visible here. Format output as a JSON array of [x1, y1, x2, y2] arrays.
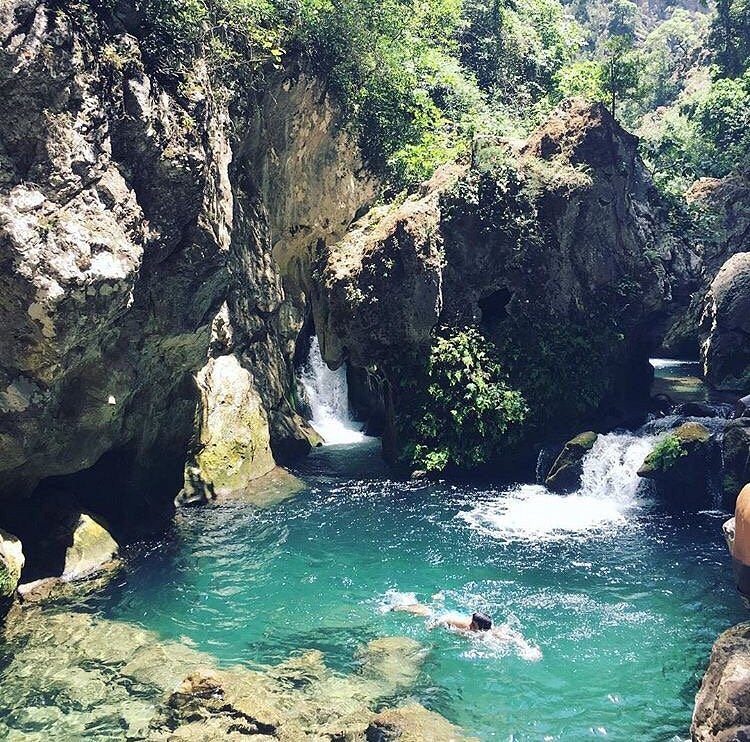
[[460, 433, 656, 541]]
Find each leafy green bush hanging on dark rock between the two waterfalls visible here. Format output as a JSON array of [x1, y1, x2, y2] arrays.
[[405, 328, 528, 472]]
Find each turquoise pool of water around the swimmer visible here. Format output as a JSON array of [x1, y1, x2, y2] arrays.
[[83, 437, 745, 740]]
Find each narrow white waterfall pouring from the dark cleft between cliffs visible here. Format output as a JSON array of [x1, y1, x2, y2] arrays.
[[299, 337, 365, 445]]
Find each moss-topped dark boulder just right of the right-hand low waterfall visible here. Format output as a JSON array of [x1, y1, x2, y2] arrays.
[[638, 422, 720, 505]]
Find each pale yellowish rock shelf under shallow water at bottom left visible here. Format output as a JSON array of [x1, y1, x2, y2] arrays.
[[0, 605, 470, 742]]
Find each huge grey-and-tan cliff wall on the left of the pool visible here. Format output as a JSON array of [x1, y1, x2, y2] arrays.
[[0, 0, 373, 532]]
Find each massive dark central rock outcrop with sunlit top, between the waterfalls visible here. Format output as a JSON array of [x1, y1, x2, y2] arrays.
[[313, 100, 694, 462]]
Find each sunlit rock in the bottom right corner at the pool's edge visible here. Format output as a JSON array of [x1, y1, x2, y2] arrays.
[[690, 623, 750, 742]]
